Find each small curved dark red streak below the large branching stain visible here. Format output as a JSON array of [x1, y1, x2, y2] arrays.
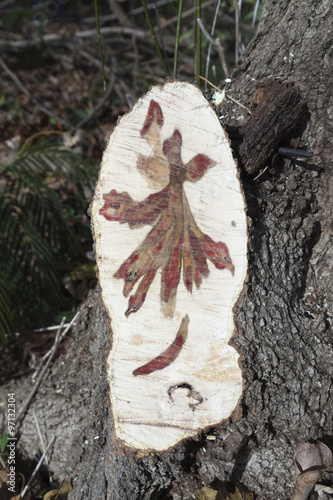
[[133, 314, 190, 376]]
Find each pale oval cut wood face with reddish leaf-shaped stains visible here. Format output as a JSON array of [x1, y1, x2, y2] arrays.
[[92, 81, 247, 450]]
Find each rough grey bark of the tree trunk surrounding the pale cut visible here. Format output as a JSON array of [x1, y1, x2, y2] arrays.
[[2, 0, 333, 500]]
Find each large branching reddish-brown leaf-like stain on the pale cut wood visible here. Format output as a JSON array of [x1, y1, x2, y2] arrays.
[[100, 99, 234, 316]]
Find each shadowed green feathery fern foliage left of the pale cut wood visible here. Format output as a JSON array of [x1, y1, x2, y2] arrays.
[[0, 145, 97, 340]]
